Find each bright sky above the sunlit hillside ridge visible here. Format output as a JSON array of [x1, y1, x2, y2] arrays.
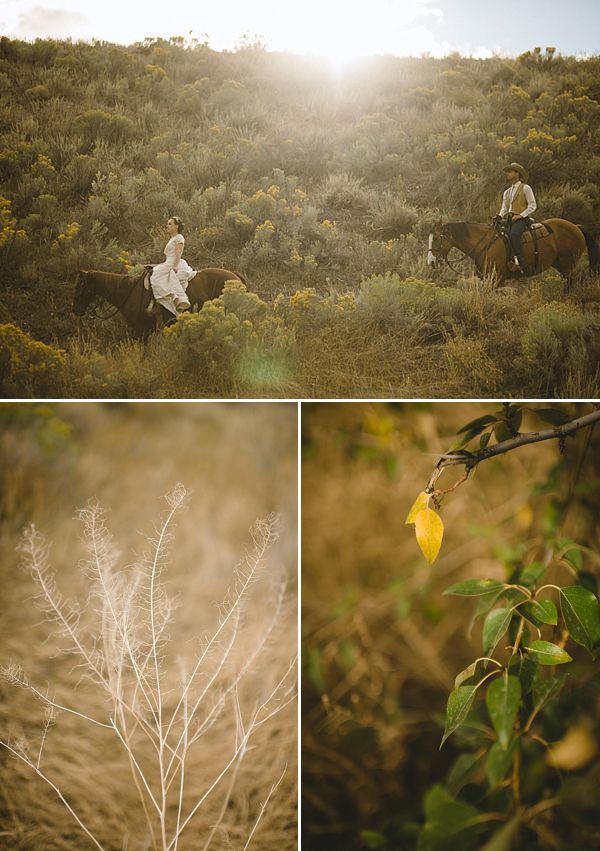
[[0, 0, 600, 65]]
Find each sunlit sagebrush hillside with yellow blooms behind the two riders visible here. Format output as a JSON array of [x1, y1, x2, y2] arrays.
[[0, 38, 600, 397]]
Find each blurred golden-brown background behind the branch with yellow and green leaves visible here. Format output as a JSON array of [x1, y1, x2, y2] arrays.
[[302, 402, 600, 851]]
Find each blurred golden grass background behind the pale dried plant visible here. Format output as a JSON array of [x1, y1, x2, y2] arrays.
[[0, 402, 298, 851]]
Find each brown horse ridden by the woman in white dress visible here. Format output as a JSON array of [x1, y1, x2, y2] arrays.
[[73, 269, 246, 340]]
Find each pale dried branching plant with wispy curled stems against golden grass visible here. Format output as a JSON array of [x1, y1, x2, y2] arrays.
[[0, 485, 296, 851]]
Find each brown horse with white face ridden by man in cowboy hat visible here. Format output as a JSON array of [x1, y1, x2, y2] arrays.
[[427, 219, 600, 283]]
